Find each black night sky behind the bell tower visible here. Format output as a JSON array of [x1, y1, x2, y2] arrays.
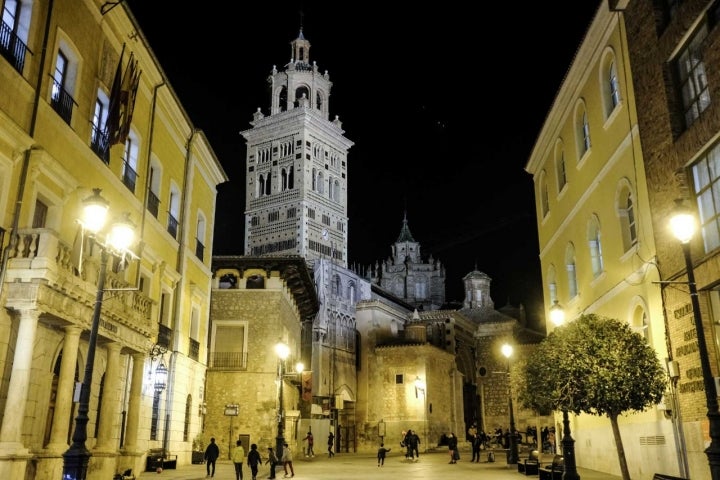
[[126, 0, 600, 324]]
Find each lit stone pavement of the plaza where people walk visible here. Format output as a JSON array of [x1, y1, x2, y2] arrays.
[[138, 448, 621, 480]]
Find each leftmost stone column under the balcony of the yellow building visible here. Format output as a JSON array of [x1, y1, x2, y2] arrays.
[[0, 309, 40, 456]]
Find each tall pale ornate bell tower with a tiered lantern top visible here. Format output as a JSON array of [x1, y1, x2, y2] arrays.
[[241, 29, 353, 267]]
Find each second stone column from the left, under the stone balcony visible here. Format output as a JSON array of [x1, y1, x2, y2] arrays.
[[46, 325, 82, 453]]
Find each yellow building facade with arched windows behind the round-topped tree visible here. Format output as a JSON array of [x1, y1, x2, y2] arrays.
[[526, 2, 681, 478]]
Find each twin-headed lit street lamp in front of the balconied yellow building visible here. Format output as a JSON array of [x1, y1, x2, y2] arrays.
[[62, 188, 134, 480]]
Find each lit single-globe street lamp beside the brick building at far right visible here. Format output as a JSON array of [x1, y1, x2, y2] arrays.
[[670, 200, 720, 480]]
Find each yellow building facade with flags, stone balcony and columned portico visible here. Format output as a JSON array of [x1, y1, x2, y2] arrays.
[[0, 0, 227, 479]]
